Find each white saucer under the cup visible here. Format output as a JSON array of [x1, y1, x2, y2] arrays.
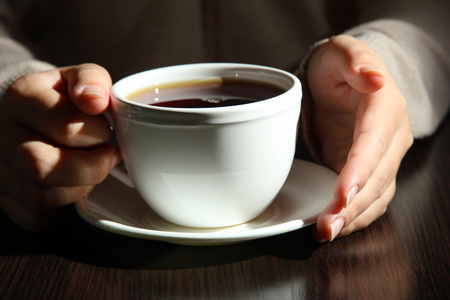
[[76, 159, 337, 245]]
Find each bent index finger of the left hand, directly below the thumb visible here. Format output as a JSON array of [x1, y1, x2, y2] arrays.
[[2, 70, 111, 148]]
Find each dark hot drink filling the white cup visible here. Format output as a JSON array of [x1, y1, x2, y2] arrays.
[[127, 78, 285, 108]]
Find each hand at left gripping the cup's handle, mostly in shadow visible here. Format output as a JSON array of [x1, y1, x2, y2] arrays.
[[0, 64, 120, 231]]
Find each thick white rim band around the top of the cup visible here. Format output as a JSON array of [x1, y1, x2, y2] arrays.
[[111, 63, 302, 125]]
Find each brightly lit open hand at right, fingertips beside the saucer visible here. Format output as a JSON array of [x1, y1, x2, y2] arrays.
[[308, 35, 413, 241]]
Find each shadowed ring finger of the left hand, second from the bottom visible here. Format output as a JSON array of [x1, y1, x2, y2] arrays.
[[0, 161, 94, 212]]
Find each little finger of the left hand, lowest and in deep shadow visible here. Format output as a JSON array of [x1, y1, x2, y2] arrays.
[[0, 194, 68, 232]]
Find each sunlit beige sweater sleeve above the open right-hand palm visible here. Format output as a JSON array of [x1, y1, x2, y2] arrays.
[[347, 14, 450, 138]]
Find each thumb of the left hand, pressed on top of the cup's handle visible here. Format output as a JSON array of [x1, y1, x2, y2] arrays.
[[62, 64, 112, 115]]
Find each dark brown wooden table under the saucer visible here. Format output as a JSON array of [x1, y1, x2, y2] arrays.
[[0, 118, 450, 300]]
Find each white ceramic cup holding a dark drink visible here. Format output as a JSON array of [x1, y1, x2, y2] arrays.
[[111, 63, 302, 228]]
